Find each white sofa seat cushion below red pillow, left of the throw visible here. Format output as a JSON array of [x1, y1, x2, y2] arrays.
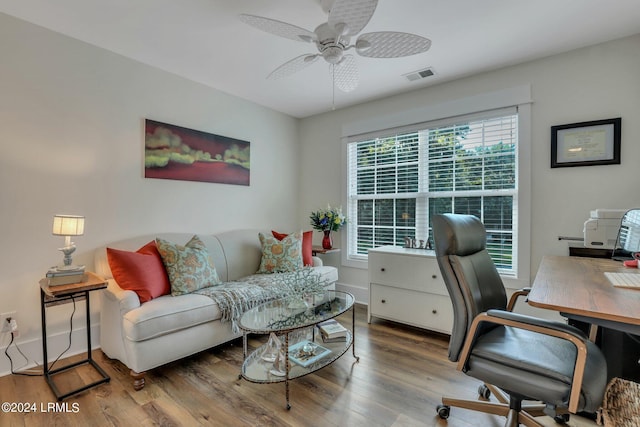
[[123, 294, 221, 341]]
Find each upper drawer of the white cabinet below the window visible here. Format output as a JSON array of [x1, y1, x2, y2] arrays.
[[369, 252, 449, 297]]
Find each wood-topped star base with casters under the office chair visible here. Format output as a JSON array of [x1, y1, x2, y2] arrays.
[[438, 384, 545, 427]]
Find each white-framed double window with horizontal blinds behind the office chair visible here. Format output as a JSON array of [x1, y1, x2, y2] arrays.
[[347, 107, 518, 276]]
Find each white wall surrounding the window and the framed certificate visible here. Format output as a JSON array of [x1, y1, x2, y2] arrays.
[[300, 35, 640, 302]]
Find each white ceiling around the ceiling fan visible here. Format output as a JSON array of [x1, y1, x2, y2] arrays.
[[0, 0, 640, 117]]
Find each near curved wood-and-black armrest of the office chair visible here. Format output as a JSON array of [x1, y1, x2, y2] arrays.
[[457, 310, 588, 414]]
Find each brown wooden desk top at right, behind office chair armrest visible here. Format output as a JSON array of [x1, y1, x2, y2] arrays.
[[528, 256, 640, 335]]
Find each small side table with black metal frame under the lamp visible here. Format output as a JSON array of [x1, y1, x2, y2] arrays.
[[40, 272, 111, 401]]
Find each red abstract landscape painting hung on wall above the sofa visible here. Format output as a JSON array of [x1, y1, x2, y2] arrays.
[[144, 119, 250, 185]]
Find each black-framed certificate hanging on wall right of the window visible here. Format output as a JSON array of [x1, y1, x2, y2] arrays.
[[551, 117, 622, 168]]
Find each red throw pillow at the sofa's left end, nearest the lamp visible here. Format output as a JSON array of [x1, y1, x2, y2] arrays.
[[107, 241, 171, 303]]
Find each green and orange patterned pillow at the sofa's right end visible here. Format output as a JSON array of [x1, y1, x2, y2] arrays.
[[258, 231, 302, 273]]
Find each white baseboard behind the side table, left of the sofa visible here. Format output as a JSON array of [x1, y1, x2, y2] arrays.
[[0, 325, 100, 377]]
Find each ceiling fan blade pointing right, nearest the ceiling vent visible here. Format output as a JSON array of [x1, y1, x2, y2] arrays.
[[356, 31, 431, 58]]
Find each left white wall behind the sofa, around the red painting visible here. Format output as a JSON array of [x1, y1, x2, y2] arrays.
[[0, 14, 299, 375]]
